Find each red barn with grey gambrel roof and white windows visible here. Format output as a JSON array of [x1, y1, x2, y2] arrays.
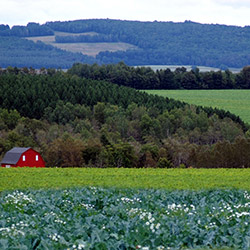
[[1, 147, 45, 168]]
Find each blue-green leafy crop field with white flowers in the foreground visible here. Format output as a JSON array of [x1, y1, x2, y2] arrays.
[[0, 187, 250, 250]]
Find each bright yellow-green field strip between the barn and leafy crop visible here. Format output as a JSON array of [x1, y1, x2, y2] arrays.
[[0, 168, 250, 191]]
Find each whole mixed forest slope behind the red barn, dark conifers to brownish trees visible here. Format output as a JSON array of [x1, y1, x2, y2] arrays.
[[0, 67, 250, 168]]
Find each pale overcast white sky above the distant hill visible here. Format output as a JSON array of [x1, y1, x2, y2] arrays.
[[0, 0, 250, 26]]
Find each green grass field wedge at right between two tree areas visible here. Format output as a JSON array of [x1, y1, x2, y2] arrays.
[[146, 90, 250, 124]]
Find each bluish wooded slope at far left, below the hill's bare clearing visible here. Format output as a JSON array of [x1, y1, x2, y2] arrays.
[[0, 36, 94, 69]]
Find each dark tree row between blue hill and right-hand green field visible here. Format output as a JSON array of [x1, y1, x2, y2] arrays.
[[68, 62, 250, 89]]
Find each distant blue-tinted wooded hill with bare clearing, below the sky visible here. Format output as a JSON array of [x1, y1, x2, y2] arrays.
[[0, 19, 250, 69]]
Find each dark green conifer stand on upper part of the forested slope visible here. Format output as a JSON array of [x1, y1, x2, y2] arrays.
[[0, 69, 183, 119]]
